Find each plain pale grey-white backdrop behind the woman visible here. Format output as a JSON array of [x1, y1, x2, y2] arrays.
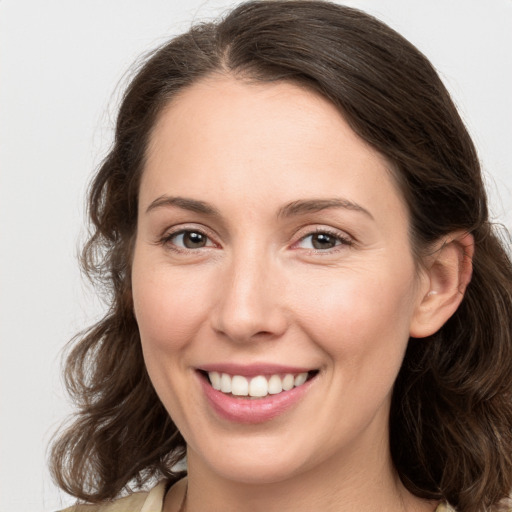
[[0, 0, 512, 512]]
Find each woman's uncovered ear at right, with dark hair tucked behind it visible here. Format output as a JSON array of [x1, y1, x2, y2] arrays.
[[409, 232, 475, 338]]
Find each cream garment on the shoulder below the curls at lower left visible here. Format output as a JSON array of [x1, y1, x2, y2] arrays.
[[60, 481, 167, 512]]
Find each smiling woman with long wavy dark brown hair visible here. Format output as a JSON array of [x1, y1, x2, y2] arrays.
[[52, 1, 512, 512]]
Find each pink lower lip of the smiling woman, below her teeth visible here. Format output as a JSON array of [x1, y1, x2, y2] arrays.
[[199, 375, 315, 423]]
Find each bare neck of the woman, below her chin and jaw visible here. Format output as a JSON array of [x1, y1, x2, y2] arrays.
[[179, 443, 436, 512]]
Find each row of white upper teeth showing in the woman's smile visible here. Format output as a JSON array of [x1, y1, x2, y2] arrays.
[[208, 372, 308, 397]]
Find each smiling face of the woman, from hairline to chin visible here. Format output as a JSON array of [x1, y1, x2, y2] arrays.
[[132, 77, 425, 482]]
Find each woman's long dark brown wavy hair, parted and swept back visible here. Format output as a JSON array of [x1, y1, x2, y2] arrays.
[[51, 0, 512, 512]]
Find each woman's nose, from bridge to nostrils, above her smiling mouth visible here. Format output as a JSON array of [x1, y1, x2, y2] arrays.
[[211, 252, 288, 342]]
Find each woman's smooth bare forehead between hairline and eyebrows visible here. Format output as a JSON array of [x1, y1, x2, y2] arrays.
[[140, 76, 404, 224]]
